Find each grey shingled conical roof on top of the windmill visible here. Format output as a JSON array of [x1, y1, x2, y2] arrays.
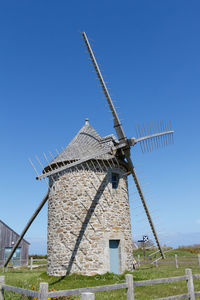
[[50, 119, 118, 165]]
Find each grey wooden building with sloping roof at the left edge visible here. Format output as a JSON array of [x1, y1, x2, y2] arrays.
[[0, 220, 30, 266]]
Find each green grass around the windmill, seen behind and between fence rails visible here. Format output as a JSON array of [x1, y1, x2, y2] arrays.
[[0, 250, 200, 300]]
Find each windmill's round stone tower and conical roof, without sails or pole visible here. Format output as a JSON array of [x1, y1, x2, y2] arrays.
[[46, 120, 133, 276]]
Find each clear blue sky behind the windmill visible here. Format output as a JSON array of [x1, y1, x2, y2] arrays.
[[0, 0, 200, 253]]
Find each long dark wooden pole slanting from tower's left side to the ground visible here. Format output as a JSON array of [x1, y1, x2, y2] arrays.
[[4, 191, 49, 267]]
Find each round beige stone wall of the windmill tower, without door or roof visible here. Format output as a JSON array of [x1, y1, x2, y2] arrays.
[[48, 161, 133, 276]]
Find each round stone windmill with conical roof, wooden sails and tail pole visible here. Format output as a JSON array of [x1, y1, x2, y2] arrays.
[[5, 33, 173, 276]]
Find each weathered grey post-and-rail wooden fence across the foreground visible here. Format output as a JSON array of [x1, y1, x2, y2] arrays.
[[0, 269, 200, 300]]
